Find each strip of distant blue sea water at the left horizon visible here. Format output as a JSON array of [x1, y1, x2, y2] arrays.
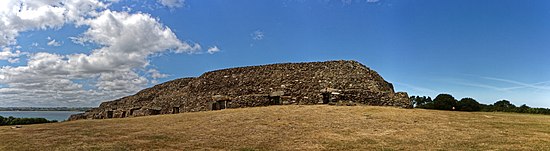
[[0, 111, 83, 122]]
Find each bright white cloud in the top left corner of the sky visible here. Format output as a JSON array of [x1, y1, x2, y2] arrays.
[[0, 0, 107, 46]]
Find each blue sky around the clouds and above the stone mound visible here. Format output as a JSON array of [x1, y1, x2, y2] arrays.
[[0, 0, 550, 107]]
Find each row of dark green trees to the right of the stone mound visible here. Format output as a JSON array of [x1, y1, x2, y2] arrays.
[[410, 94, 550, 114]]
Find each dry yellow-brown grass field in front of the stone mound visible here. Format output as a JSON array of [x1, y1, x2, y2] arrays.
[[0, 105, 550, 150]]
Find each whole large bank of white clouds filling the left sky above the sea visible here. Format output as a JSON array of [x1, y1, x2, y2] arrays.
[[0, 0, 206, 106]]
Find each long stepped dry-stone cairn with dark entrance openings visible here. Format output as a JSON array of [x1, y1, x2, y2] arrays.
[[69, 60, 412, 120]]
